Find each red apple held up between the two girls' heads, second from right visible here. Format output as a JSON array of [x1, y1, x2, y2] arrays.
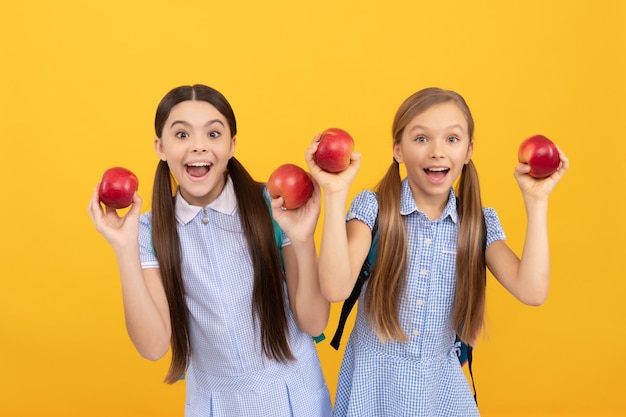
[[313, 127, 354, 172]]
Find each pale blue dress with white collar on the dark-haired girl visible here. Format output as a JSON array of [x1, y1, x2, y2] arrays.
[[139, 179, 331, 417]]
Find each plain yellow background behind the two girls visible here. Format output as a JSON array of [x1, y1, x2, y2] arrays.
[[0, 0, 626, 417]]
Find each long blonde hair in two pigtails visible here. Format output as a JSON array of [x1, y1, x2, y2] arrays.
[[365, 88, 486, 344]]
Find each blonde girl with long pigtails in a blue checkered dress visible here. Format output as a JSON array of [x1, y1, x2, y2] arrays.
[[307, 88, 569, 417]]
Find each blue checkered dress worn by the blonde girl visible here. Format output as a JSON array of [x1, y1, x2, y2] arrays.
[[333, 179, 504, 417]]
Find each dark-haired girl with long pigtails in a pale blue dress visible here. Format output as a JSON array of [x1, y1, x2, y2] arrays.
[[89, 85, 331, 417]]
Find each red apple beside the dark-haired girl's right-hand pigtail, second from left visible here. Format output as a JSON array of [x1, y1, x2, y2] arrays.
[[267, 164, 313, 209]]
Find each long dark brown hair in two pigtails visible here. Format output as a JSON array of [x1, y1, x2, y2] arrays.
[[152, 84, 294, 384]]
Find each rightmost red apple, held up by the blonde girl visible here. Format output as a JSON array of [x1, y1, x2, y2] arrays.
[[517, 135, 561, 178]]
